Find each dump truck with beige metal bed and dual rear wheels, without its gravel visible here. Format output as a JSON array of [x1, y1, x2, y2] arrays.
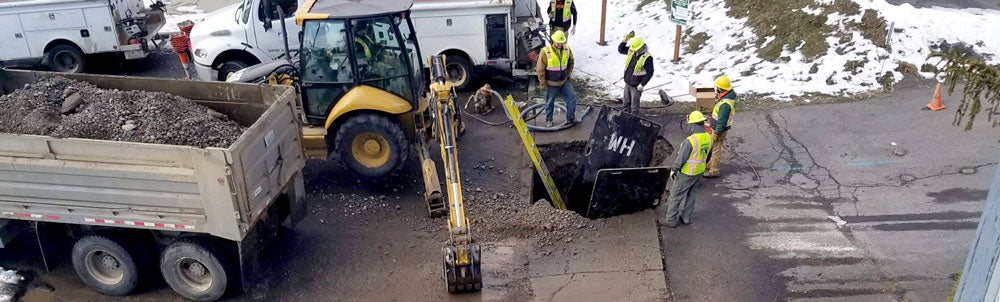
[[0, 69, 306, 301]]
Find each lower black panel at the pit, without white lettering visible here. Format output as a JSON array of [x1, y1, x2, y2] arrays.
[[586, 167, 670, 218]]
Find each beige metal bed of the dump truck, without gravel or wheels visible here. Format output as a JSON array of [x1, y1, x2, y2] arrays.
[[0, 69, 305, 241]]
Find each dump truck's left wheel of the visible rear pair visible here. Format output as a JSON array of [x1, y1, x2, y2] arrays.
[[72, 235, 140, 296]]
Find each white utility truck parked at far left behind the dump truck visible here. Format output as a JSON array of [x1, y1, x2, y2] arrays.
[[0, 0, 165, 73]]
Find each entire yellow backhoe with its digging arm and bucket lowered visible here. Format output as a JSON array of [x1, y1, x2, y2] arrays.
[[227, 0, 482, 292]]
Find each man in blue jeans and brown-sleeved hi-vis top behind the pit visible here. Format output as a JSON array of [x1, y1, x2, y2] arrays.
[[535, 30, 577, 127]]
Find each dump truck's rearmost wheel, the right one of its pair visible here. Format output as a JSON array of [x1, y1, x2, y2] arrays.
[[160, 239, 231, 301]]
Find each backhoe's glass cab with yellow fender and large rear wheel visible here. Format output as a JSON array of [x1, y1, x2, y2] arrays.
[[295, 0, 427, 177]]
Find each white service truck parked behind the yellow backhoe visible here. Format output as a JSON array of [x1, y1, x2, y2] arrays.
[[191, 0, 545, 89]]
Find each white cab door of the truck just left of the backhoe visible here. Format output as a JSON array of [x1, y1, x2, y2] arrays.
[[253, 0, 301, 59]]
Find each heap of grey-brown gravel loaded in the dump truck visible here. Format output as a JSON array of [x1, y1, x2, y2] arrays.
[[0, 77, 246, 148]]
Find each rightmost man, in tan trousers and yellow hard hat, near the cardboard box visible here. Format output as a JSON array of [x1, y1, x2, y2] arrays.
[[705, 75, 736, 178]]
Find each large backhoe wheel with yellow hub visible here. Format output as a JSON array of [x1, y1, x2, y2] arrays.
[[334, 113, 409, 177]]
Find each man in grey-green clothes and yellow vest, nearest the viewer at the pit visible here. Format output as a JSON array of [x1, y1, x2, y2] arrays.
[[662, 110, 712, 227]]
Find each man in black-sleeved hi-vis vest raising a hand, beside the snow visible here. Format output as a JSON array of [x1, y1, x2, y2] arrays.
[[618, 31, 653, 114]]
